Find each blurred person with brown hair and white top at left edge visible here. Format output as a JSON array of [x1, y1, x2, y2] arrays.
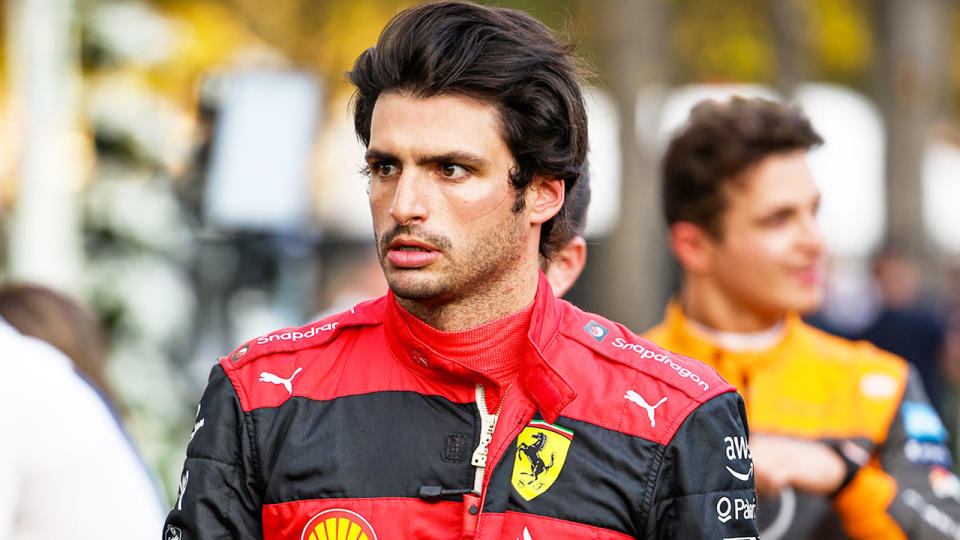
[[0, 285, 163, 540]]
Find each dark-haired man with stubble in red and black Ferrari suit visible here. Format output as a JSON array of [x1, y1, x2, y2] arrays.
[[167, 2, 756, 540]]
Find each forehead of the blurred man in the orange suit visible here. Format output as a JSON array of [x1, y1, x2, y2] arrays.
[[724, 150, 820, 214]]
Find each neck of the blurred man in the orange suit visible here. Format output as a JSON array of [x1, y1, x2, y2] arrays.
[[680, 277, 786, 332]]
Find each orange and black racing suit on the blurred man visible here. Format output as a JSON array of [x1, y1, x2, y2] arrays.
[[644, 302, 960, 540]]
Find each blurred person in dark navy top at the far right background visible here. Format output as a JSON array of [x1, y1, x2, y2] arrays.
[[855, 246, 946, 412]]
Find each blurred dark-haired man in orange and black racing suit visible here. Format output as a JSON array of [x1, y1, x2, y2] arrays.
[[645, 98, 960, 540]]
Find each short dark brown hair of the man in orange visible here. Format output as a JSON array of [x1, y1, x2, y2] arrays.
[[662, 97, 823, 238]]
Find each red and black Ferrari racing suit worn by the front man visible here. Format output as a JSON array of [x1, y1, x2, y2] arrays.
[[165, 275, 757, 540]]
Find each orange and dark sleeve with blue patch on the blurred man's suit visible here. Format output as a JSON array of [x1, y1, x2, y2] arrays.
[[834, 367, 960, 540]]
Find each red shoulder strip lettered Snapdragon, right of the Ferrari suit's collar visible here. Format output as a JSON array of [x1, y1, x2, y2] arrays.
[[560, 307, 732, 402]]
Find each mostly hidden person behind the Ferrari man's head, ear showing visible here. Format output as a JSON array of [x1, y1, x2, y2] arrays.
[[540, 167, 590, 298]]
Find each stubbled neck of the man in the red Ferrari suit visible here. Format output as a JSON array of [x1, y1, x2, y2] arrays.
[[397, 263, 539, 332]]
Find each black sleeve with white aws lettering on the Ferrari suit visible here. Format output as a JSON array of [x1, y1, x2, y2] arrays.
[[644, 392, 759, 540]]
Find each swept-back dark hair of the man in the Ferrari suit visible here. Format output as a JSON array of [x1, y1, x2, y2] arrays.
[[347, 2, 587, 257]]
